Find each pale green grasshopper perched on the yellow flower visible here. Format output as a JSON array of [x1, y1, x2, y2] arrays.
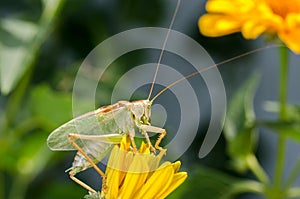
[[47, 0, 181, 194]]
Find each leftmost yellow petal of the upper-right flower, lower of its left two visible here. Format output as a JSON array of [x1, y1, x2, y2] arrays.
[[198, 14, 241, 37]]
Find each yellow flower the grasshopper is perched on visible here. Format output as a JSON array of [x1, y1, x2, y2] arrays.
[[101, 136, 187, 199]]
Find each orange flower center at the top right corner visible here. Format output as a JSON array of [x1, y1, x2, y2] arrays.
[[265, 0, 300, 18]]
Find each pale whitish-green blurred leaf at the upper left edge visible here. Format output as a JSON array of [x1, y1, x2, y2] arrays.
[[0, 19, 38, 94]]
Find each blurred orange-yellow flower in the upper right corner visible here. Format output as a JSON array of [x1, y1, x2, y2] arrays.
[[198, 0, 300, 53]]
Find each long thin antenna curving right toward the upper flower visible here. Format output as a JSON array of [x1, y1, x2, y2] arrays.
[[151, 44, 282, 103]]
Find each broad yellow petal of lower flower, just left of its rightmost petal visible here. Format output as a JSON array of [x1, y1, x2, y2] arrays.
[[136, 162, 174, 199]]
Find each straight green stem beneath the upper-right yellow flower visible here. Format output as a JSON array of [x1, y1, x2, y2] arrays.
[[274, 47, 288, 190]]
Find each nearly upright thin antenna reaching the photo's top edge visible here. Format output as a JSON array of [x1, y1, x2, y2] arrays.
[[147, 0, 181, 100]]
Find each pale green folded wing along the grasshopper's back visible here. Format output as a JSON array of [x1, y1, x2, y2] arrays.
[[47, 107, 132, 151]]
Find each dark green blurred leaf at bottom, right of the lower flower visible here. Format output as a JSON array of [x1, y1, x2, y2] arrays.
[[168, 166, 262, 199]]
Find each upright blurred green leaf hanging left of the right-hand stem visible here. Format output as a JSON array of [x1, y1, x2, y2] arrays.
[[224, 74, 259, 172]]
